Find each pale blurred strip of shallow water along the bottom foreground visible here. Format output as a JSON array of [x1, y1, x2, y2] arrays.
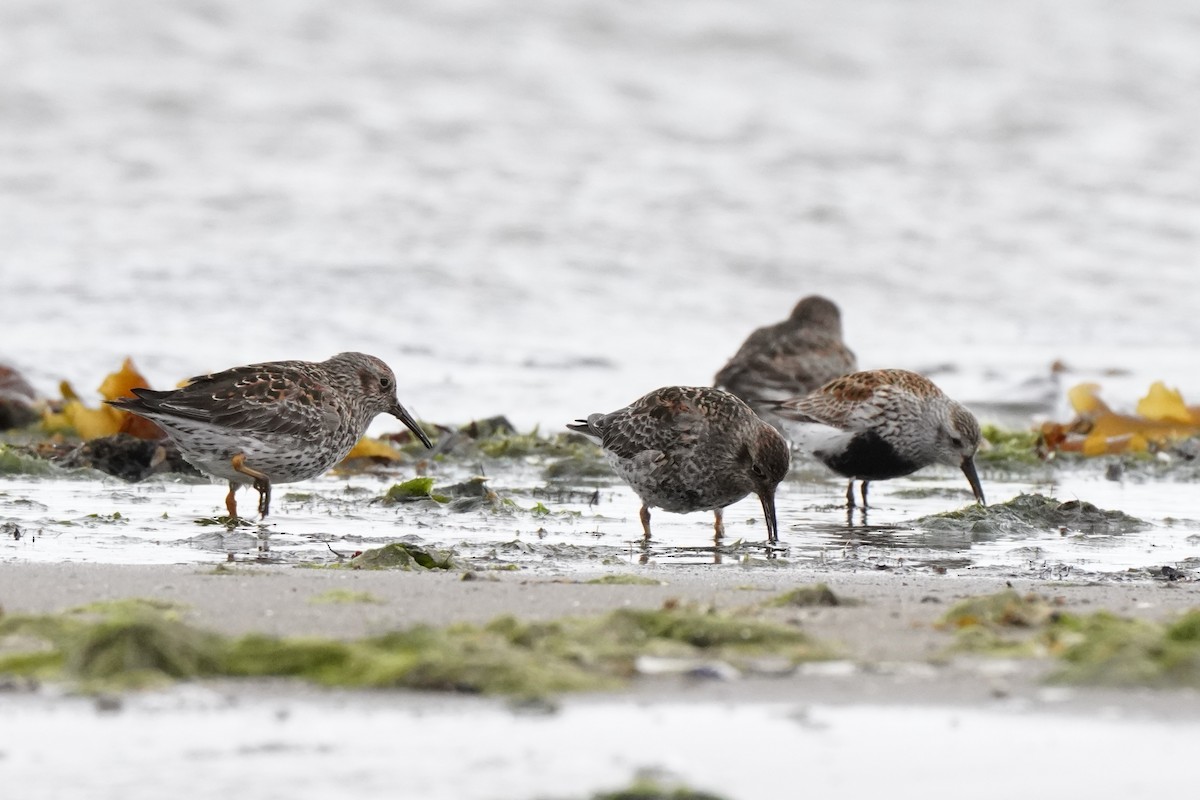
[[0, 690, 1200, 800]]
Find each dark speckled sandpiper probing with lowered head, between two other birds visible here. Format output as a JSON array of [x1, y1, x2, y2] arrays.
[[566, 386, 791, 543]]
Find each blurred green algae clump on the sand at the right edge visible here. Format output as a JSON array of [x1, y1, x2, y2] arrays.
[[938, 590, 1200, 688]]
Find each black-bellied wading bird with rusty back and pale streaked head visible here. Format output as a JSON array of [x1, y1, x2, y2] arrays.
[[775, 369, 984, 509]]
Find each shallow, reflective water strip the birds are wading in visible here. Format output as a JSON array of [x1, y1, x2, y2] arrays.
[[0, 462, 1200, 579]]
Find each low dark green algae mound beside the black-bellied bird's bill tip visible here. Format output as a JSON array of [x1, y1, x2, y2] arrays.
[[913, 494, 1150, 535]]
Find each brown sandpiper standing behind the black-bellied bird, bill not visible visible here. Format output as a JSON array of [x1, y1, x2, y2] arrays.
[[713, 295, 857, 431]]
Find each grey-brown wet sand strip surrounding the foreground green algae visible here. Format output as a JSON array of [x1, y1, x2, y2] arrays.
[[0, 564, 1200, 716]]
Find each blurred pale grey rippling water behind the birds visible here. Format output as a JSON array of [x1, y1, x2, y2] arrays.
[[0, 0, 1200, 429]]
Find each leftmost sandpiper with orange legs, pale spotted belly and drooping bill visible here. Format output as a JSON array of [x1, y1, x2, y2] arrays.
[[109, 353, 431, 518]]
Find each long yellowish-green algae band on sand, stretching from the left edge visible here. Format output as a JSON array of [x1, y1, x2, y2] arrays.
[[0, 602, 830, 696]]
